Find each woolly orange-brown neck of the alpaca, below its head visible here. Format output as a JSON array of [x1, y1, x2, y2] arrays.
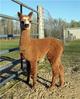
[[20, 29, 30, 49]]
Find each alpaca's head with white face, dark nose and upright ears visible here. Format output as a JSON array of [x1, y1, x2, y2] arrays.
[[18, 12, 33, 30]]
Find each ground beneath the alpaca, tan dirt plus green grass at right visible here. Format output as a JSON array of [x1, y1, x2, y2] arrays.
[[0, 41, 80, 99]]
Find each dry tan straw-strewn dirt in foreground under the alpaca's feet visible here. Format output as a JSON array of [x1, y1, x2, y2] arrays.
[[1, 65, 80, 99]]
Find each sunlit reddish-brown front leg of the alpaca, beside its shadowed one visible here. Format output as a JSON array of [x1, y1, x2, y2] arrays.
[[31, 61, 37, 87]]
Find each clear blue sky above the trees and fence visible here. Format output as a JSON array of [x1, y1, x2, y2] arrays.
[[0, 0, 80, 22]]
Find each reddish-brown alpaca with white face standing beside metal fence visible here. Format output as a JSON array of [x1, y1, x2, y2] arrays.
[[18, 12, 64, 87]]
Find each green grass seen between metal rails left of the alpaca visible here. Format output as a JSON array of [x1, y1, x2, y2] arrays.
[[0, 39, 19, 66]]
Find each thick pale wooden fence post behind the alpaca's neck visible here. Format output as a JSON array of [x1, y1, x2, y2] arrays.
[[37, 6, 44, 38]]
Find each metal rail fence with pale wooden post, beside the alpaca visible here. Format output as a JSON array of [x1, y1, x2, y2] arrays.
[[0, 0, 44, 85]]
